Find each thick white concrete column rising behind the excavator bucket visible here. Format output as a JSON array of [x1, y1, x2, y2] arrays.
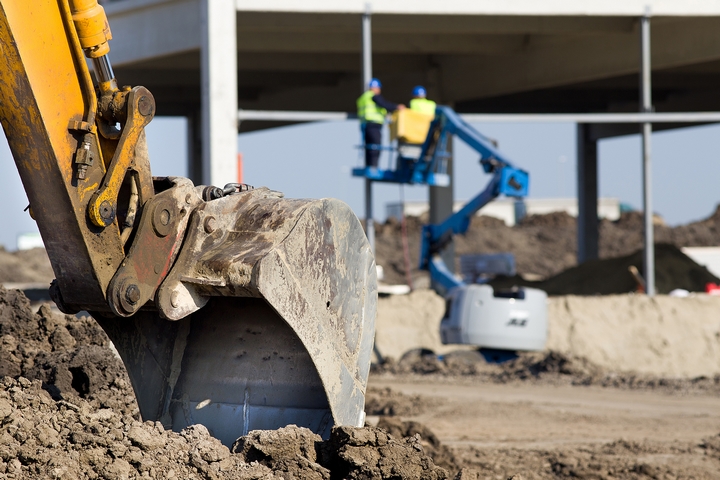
[[200, 0, 238, 187]]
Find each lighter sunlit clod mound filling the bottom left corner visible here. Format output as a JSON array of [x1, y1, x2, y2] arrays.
[[0, 377, 278, 480]]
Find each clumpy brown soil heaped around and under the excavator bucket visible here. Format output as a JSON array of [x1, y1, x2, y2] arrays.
[[0, 287, 457, 480]]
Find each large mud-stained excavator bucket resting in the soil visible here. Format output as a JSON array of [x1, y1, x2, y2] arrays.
[[95, 188, 377, 445]]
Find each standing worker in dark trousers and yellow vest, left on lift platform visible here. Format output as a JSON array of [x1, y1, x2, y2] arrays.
[[357, 78, 405, 168]]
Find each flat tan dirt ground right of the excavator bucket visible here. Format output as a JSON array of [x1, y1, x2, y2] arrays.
[[371, 375, 720, 479]]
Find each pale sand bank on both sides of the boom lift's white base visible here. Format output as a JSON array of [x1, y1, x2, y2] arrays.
[[376, 290, 720, 378]]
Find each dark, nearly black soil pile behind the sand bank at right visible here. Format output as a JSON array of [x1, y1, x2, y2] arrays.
[[489, 243, 720, 295]]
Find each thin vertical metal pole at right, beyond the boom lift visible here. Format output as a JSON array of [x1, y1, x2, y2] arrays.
[[640, 8, 655, 296]]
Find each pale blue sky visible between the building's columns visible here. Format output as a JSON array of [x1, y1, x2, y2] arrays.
[[0, 117, 720, 250]]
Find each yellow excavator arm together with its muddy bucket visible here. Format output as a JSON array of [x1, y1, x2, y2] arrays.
[[0, 0, 377, 444]]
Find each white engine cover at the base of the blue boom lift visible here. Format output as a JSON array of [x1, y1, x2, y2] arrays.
[[440, 285, 547, 350]]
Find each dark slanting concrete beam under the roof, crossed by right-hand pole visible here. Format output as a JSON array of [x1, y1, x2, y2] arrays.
[[436, 18, 720, 101]]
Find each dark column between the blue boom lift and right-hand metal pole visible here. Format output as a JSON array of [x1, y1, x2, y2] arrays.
[[577, 123, 599, 263]]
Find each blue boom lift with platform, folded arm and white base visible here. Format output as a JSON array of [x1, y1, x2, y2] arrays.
[[353, 106, 547, 350]]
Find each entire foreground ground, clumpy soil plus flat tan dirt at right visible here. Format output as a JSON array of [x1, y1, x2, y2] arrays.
[[0, 280, 720, 480]]
